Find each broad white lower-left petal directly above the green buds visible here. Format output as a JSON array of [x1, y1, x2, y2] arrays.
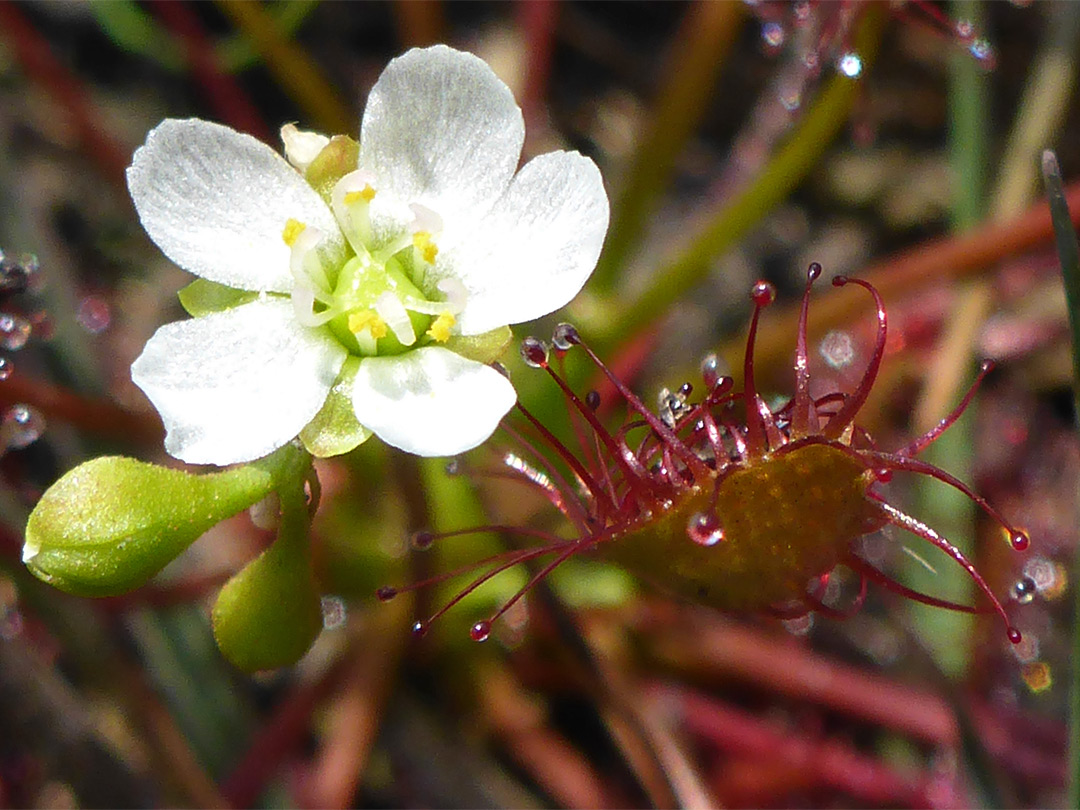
[[132, 298, 346, 464]]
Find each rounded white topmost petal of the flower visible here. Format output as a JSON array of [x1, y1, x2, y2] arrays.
[[360, 45, 525, 231]]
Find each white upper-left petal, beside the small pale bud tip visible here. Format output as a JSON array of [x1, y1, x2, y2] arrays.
[[127, 119, 345, 293]]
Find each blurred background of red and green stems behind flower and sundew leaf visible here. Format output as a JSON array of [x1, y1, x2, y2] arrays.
[[0, 0, 1080, 807]]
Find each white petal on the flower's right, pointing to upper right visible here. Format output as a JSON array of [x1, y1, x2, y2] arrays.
[[435, 152, 608, 335]]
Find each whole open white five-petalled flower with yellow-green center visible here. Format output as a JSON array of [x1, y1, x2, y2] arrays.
[[127, 45, 608, 464]]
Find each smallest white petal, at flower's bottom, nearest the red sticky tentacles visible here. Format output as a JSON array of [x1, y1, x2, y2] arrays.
[[352, 347, 517, 456]]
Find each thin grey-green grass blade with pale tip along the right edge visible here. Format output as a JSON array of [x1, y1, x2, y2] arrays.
[[1042, 150, 1080, 807]]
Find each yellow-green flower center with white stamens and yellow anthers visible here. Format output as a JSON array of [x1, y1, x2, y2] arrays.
[[282, 171, 465, 356]]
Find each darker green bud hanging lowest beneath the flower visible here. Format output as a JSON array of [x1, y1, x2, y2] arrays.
[[211, 515, 323, 672]]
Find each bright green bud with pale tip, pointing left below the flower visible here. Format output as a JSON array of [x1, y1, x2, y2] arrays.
[[23, 456, 274, 596]]
